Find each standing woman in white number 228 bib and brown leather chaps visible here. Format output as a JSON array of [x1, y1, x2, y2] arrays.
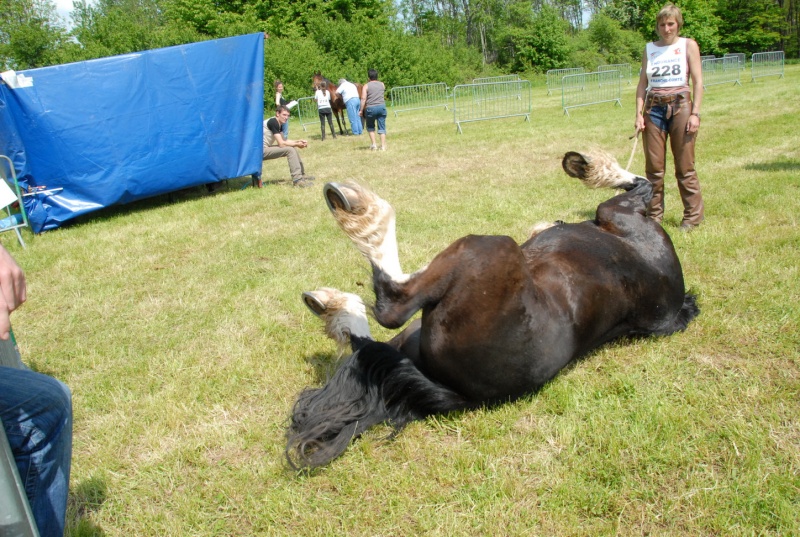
[[636, 4, 704, 231]]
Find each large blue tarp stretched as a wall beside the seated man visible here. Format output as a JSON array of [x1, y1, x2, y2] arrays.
[[0, 33, 264, 233]]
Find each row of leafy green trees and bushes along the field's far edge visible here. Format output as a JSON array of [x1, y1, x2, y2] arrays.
[[0, 0, 800, 100]]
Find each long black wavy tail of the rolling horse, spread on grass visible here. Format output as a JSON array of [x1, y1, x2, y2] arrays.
[[286, 342, 469, 470]]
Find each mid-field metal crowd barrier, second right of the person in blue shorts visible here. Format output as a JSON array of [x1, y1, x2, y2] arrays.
[[453, 80, 531, 133]]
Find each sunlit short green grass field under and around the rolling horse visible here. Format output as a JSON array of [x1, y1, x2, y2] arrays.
[[7, 65, 800, 537]]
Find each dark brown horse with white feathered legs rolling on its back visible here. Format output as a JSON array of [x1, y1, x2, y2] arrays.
[[286, 152, 700, 469]]
